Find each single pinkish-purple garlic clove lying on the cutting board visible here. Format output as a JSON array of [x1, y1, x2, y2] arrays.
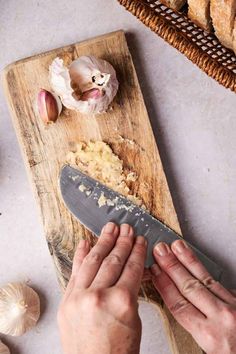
[[38, 89, 62, 124]]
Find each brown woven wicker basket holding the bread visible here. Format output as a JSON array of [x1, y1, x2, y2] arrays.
[[118, 0, 236, 92]]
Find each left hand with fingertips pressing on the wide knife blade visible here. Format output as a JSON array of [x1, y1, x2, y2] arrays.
[[58, 223, 147, 354]]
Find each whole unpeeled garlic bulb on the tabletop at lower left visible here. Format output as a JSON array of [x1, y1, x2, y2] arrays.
[[0, 283, 40, 336]]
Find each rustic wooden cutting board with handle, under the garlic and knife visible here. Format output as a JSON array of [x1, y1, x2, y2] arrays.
[[0, 31, 202, 354]]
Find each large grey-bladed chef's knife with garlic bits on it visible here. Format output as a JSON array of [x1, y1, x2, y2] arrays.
[[59, 165, 222, 280]]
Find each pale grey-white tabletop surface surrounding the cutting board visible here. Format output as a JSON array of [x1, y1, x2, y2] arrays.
[[0, 0, 236, 354]]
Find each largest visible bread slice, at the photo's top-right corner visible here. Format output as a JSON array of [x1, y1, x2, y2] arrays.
[[210, 0, 236, 49]]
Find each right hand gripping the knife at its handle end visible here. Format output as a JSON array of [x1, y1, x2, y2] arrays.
[[152, 240, 236, 354]]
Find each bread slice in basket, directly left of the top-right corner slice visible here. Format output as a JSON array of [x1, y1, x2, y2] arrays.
[[188, 0, 212, 31]]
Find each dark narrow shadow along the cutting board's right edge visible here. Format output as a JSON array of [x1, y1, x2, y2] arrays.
[[126, 32, 236, 288]]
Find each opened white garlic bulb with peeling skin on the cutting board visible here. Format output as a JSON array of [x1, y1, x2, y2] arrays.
[[49, 56, 119, 114]]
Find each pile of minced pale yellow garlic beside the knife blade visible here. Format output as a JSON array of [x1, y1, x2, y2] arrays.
[[67, 141, 143, 206]]
